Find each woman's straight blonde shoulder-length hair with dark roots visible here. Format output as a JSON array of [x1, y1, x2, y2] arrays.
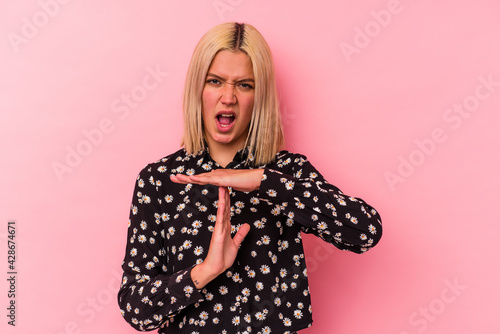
[[181, 22, 284, 166]]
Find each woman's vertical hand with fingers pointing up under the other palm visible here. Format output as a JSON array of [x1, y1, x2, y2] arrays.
[[191, 187, 250, 289]]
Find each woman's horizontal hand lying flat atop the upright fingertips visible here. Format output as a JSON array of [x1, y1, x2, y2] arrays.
[[170, 168, 264, 191]]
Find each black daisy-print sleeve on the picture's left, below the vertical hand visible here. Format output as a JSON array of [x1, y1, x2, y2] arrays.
[[118, 167, 203, 331]]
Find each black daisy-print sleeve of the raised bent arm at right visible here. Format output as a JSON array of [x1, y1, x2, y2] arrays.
[[259, 154, 382, 253]]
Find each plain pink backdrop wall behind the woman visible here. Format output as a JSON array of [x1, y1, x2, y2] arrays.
[[0, 0, 500, 334]]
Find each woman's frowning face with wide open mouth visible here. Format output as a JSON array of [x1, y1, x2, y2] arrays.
[[202, 50, 255, 149]]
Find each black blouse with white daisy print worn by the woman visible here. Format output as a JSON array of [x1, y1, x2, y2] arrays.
[[118, 149, 382, 334]]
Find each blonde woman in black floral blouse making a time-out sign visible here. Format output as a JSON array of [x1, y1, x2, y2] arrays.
[[118, 23, 382, 334]]
